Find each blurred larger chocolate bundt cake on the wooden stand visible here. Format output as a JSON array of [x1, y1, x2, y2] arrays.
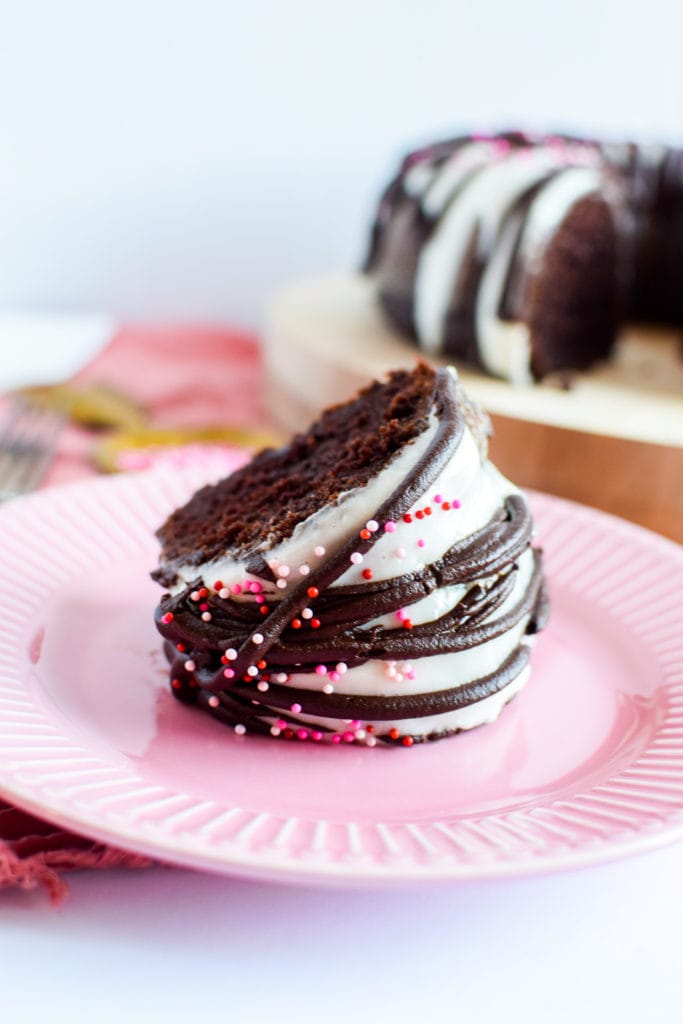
[[365, 132, 683, 383]]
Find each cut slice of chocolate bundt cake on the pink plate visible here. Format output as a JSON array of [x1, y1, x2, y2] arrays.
[[153, 364, 547, 746]]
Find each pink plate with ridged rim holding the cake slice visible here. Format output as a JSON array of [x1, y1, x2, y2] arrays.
[[0, 466, 683, 883]]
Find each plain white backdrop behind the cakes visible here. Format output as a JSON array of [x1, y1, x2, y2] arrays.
[[0, 0, 683, 325]]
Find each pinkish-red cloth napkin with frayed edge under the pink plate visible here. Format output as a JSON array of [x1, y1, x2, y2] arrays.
[[0, 327, 266, 902]]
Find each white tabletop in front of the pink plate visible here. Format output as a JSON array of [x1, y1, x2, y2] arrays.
[[0, 843, 683, 1024]]
